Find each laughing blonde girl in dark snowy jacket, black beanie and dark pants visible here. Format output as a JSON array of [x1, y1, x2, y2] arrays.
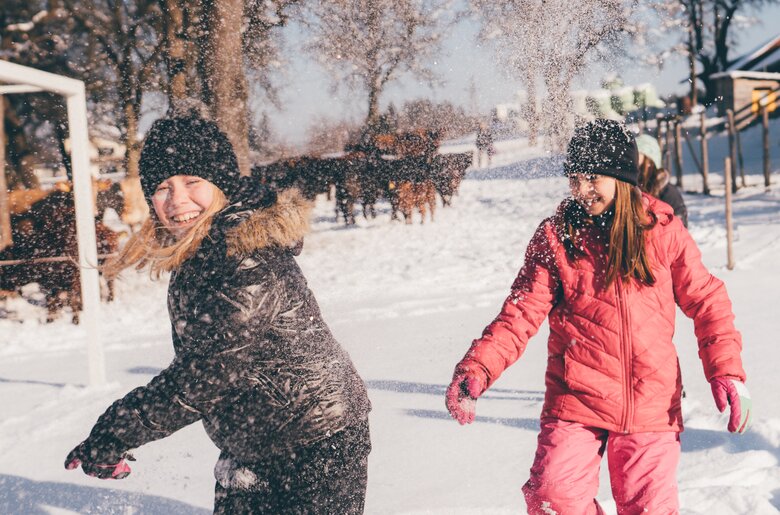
[[65, 115, 370, 514]]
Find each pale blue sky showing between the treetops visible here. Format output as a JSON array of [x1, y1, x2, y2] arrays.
[[268, 5, 780, 144]]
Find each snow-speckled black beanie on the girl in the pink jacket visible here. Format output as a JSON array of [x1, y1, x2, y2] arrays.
[[563, 118, 639, 186]]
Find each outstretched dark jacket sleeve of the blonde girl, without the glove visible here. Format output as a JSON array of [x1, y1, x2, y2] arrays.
[[66, 256, 279, 478]]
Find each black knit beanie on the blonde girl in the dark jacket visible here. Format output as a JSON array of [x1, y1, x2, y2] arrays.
[[139, 114, 241, 199]]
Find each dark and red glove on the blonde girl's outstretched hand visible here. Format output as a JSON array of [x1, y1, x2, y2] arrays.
[[65, 437, 135, 479]]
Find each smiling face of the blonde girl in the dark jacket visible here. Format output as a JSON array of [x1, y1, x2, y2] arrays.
[[152, 175, 215, 238]]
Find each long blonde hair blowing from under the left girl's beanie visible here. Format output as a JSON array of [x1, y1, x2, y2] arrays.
[[103, 184, 227, 279]]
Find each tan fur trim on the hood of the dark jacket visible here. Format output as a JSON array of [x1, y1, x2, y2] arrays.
[[225, 189, 312, 256]]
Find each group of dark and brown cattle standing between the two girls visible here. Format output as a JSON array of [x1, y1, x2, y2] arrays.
[[252, 152, 472, 225]]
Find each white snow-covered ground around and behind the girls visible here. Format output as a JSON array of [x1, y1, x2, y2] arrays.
[[0, 135, 780, 515]]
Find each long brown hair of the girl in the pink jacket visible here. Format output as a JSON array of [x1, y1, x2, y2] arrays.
[[560, 181, 656, 288]]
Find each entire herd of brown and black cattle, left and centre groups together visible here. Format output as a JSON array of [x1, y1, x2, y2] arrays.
[[0, 146, 472, 323]]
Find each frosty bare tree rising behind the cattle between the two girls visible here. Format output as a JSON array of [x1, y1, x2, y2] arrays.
[[308, 0, 454, 131]]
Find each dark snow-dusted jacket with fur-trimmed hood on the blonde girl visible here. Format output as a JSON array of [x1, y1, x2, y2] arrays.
[[84, 189, 370, 462]]
